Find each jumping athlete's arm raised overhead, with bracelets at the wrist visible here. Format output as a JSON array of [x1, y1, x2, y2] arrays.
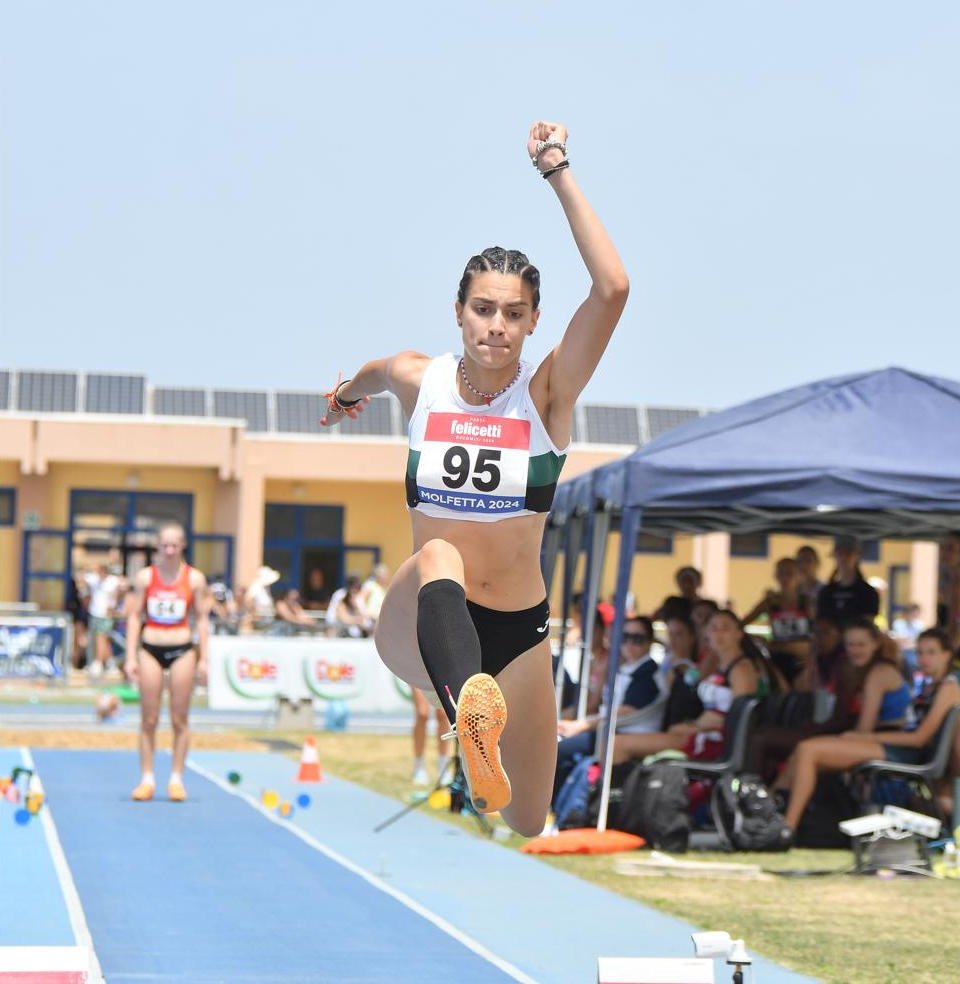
[[527, 122, 630, 418]]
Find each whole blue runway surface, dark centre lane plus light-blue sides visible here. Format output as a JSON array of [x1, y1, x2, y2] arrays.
[[0, 739, 816, 984]]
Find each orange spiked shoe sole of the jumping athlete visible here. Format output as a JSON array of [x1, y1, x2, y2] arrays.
[[457, 673, 511, 813]]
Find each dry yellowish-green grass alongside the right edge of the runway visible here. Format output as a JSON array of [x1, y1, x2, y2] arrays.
[[245, 732, 960, 984]]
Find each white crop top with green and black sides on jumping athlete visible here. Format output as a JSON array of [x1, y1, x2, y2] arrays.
[[406, 353, 566, 523]]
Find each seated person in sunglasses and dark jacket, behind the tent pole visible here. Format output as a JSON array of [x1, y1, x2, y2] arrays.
[[553, 615, 666, 797]]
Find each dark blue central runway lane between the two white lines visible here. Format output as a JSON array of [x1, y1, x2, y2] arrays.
[[34, 750, 511, 984]]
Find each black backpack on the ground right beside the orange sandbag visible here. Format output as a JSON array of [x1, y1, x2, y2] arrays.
[[607, 762, 690, 854]]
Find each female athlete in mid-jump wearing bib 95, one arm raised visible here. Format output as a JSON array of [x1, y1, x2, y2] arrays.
[[322, 122, 628, 836]]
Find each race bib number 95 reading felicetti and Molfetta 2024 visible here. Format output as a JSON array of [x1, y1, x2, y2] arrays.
[[417, 413, 530, 515]]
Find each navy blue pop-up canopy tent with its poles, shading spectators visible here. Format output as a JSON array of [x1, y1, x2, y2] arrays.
[[543, 368, 960, 823]]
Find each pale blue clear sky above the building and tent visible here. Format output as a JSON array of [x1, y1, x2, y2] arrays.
[[0, 0, 960, 407]]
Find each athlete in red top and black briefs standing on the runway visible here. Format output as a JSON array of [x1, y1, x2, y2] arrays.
[[124, 523, 210, 801]]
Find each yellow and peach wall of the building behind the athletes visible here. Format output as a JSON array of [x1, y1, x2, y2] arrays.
[[0, 416, 928, 624]]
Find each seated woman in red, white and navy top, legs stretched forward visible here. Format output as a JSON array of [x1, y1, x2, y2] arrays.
[[613, 609, 777, 765]]
